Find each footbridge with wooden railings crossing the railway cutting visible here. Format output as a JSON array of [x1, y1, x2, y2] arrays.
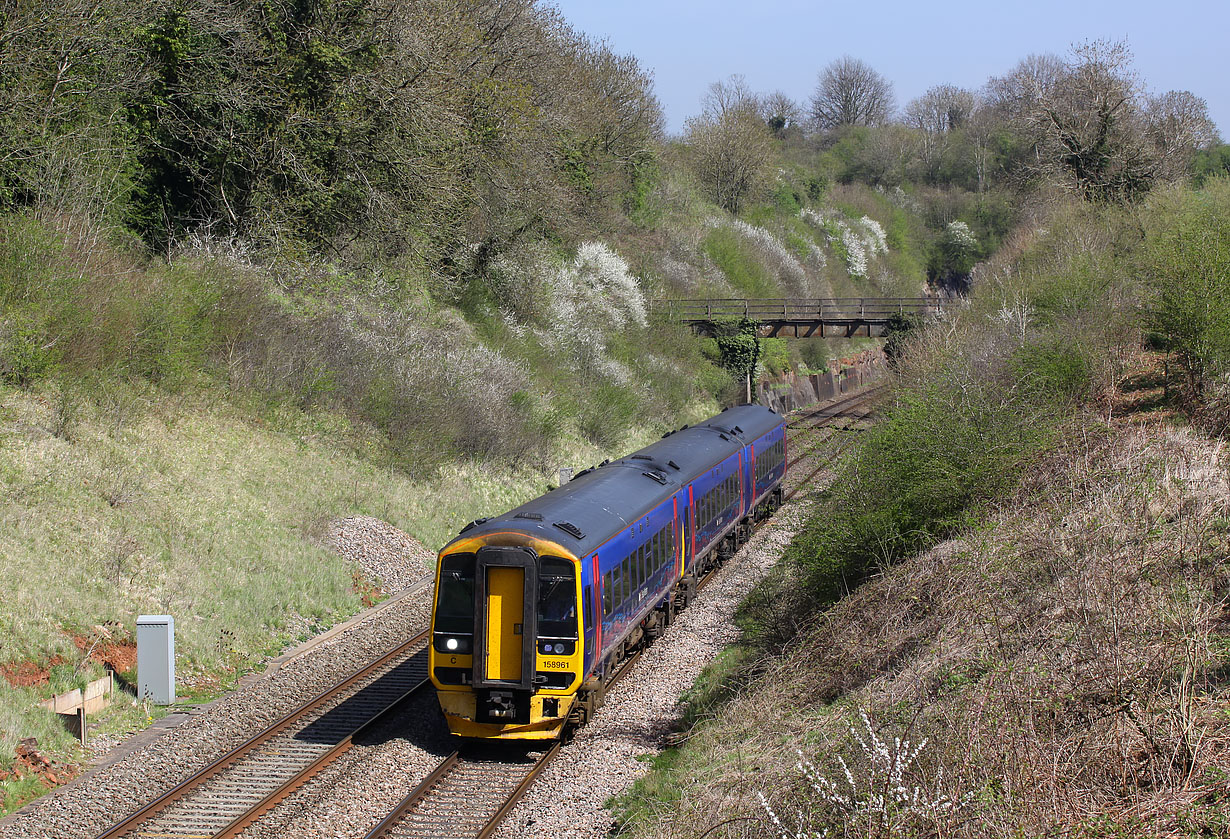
[[649, 298, 957, 338]]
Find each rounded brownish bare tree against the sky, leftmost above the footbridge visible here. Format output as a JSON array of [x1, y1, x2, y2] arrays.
[[684, 76, 772, 213]]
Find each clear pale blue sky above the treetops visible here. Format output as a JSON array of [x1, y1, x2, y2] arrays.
[[549, 0, 1230, 139]]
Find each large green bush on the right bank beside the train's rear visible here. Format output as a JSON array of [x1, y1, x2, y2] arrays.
[[782, 322, 1072, 624]]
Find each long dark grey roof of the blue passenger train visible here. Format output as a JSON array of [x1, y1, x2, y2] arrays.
[[447, 405, 782, 556]]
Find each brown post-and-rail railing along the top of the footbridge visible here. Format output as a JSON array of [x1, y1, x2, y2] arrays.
[[649, 298, 954, 321]]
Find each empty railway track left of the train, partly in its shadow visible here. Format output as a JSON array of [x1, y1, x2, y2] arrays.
[[97, 630, 429, 839]]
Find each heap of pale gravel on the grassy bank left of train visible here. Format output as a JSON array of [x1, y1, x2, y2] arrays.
[[325, 515, 435, 594]]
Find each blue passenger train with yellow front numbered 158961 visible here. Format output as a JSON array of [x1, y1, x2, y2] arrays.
[[428, 405, 788, 741]]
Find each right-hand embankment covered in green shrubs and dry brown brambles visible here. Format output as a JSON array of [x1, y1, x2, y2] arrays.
[[620, 180, 1230, 837]]
